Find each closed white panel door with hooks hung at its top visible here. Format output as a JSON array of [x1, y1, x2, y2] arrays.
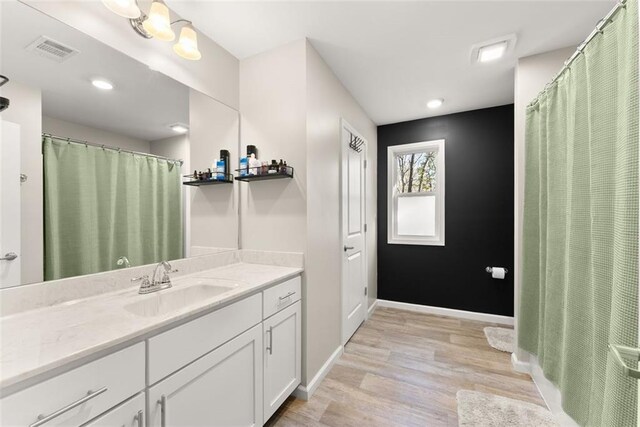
[[341, 121, 367, 344]]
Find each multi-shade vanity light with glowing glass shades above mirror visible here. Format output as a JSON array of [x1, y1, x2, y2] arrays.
[[102, 0, 202, 61]]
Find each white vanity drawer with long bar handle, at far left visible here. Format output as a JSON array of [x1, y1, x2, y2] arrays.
[[0, 343, 145, 427]]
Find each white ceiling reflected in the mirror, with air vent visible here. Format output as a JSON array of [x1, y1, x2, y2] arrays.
[[0, 2, 189, 141]]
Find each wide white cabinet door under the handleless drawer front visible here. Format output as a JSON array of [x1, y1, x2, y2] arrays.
[[147, 325, 263, 427]]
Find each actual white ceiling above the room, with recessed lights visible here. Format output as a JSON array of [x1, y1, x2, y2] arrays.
[[168, 0, 615, 124]]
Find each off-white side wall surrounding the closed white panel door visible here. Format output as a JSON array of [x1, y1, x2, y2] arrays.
[[304, 42, 377, 379]]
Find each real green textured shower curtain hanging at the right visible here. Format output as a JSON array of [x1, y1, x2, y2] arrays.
[[518, 0, 639, 427]]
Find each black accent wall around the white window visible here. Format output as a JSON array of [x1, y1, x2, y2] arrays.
[[377, 105, 514, 316]]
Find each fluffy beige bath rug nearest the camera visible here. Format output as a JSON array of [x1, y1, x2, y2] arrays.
[[456, 390, 560, 427]]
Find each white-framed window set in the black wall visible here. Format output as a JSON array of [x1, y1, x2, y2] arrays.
[[387, 139, 444, 246]]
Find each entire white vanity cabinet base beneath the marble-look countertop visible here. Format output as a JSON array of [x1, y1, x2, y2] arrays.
[[0, 276, 301, 427]]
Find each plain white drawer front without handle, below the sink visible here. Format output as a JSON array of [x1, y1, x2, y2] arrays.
[[148, 294, 262, 385]]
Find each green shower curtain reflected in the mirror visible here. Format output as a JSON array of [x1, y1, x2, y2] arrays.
[[42, 136, 183, 280]]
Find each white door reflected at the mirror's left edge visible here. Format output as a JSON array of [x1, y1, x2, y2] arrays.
[[0, 120, 20, 288]]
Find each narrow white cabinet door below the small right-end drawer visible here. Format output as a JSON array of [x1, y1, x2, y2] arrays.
[[263, 301, 301, 420]]
